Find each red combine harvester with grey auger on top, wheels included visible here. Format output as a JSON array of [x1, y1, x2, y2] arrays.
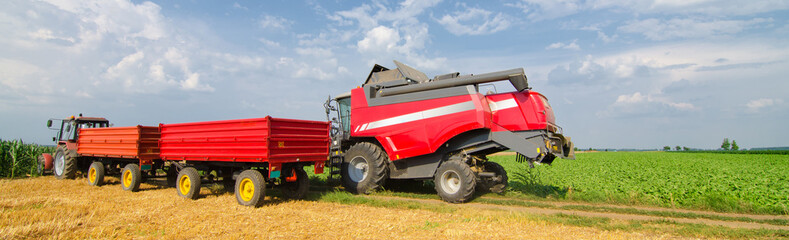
[[324, 61, 574, 203]]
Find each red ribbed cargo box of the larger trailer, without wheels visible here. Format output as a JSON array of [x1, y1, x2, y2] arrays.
[[159, 116, 330, 163]]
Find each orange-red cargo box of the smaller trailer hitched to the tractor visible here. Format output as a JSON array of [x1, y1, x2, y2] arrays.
[[77, 125, 159, 164]]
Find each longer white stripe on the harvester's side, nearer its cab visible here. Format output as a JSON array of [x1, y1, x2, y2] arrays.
[[360, 101, 476, 131]]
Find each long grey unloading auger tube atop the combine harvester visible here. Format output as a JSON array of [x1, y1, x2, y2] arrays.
[[376, 68, 529, 97]]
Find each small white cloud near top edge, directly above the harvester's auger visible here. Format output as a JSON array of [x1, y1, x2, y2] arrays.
[[438, 4, 512, 36]]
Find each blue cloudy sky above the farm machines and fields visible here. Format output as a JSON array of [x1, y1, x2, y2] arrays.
[[0, 0, 789, 148]]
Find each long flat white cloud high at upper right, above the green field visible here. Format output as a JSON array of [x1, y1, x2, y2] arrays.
[[619, 18, 772, 41]]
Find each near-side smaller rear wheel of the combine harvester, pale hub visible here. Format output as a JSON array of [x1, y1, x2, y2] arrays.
[[434, 161, 477, 203]]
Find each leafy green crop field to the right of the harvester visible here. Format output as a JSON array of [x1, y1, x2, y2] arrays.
[[490, 152, 789, 214]]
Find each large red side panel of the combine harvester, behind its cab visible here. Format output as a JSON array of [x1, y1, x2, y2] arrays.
[[350, 89, 489, 161]]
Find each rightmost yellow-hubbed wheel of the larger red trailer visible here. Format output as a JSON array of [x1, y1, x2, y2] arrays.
[[234, 170, 266, 207]]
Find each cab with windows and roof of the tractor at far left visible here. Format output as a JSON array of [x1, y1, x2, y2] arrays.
[[47, 114, 110, 144]]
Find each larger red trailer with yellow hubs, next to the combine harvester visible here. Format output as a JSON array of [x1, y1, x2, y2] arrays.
[[159, 116, 331, 206]]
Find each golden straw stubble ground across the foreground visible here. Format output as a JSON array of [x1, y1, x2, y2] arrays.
[[0, 176, 780, 239]]
